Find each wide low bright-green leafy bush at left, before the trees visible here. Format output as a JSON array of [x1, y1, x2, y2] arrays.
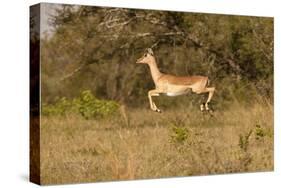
[[42, 90, 119, 119]]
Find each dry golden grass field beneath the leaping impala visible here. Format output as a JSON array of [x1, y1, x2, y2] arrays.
[[41, 102, 274, 184]]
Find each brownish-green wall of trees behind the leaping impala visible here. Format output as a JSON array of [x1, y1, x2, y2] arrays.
[[41, 5, 273, 106]]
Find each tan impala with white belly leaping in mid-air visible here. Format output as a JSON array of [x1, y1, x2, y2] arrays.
[[136, 48, 215, 113]]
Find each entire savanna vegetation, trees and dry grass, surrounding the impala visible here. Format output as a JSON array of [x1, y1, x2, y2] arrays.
[[34, 5, 274, 184]]
